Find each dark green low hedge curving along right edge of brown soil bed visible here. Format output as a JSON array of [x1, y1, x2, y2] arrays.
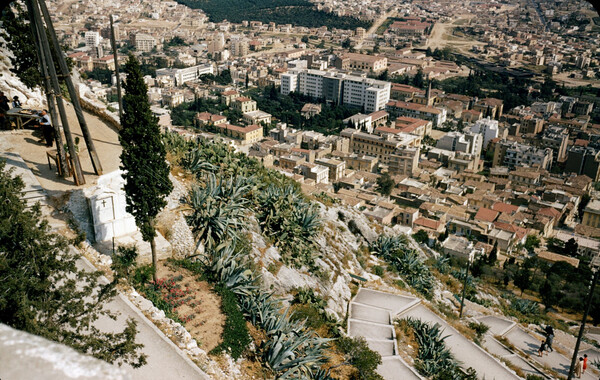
[[211, 285, 252, 359]]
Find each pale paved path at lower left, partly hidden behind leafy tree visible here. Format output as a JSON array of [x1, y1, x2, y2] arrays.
[[2, 147, 210, 380]]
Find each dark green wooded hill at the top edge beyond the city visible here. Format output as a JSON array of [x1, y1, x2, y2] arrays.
[[177, 0, 371, 29]]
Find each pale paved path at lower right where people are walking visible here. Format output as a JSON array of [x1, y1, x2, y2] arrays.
[[478, 316, 598, 380]]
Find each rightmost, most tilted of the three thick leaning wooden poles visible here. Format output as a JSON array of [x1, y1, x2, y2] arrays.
[[38, 0, 102, 175]]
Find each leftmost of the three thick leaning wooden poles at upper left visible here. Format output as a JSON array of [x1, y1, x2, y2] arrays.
[[25, 0, 69, 177]]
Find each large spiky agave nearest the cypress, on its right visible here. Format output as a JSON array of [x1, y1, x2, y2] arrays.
[[185, 173, 250, 252]]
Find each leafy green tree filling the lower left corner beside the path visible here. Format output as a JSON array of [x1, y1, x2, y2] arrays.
[[0, 160, 146, 367]]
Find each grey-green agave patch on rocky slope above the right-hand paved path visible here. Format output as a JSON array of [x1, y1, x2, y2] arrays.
[[369, 235, 435, 297]]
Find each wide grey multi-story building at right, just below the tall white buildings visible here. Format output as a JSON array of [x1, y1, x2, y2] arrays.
[[492, 140, 552, 170]]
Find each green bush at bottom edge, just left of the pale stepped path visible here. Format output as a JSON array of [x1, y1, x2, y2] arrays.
[[336, 336, 383, 380]]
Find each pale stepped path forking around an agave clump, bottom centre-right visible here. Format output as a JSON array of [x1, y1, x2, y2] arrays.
[[348, 288, 519, 380]]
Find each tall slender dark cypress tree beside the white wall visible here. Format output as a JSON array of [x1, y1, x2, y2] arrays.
[[119, 56, 173, 281]]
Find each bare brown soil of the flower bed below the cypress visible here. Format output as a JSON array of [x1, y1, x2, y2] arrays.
[[157, 262, 225, 351]]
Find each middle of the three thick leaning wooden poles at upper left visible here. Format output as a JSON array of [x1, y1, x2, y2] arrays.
[[31, 0, 85, 185]]
